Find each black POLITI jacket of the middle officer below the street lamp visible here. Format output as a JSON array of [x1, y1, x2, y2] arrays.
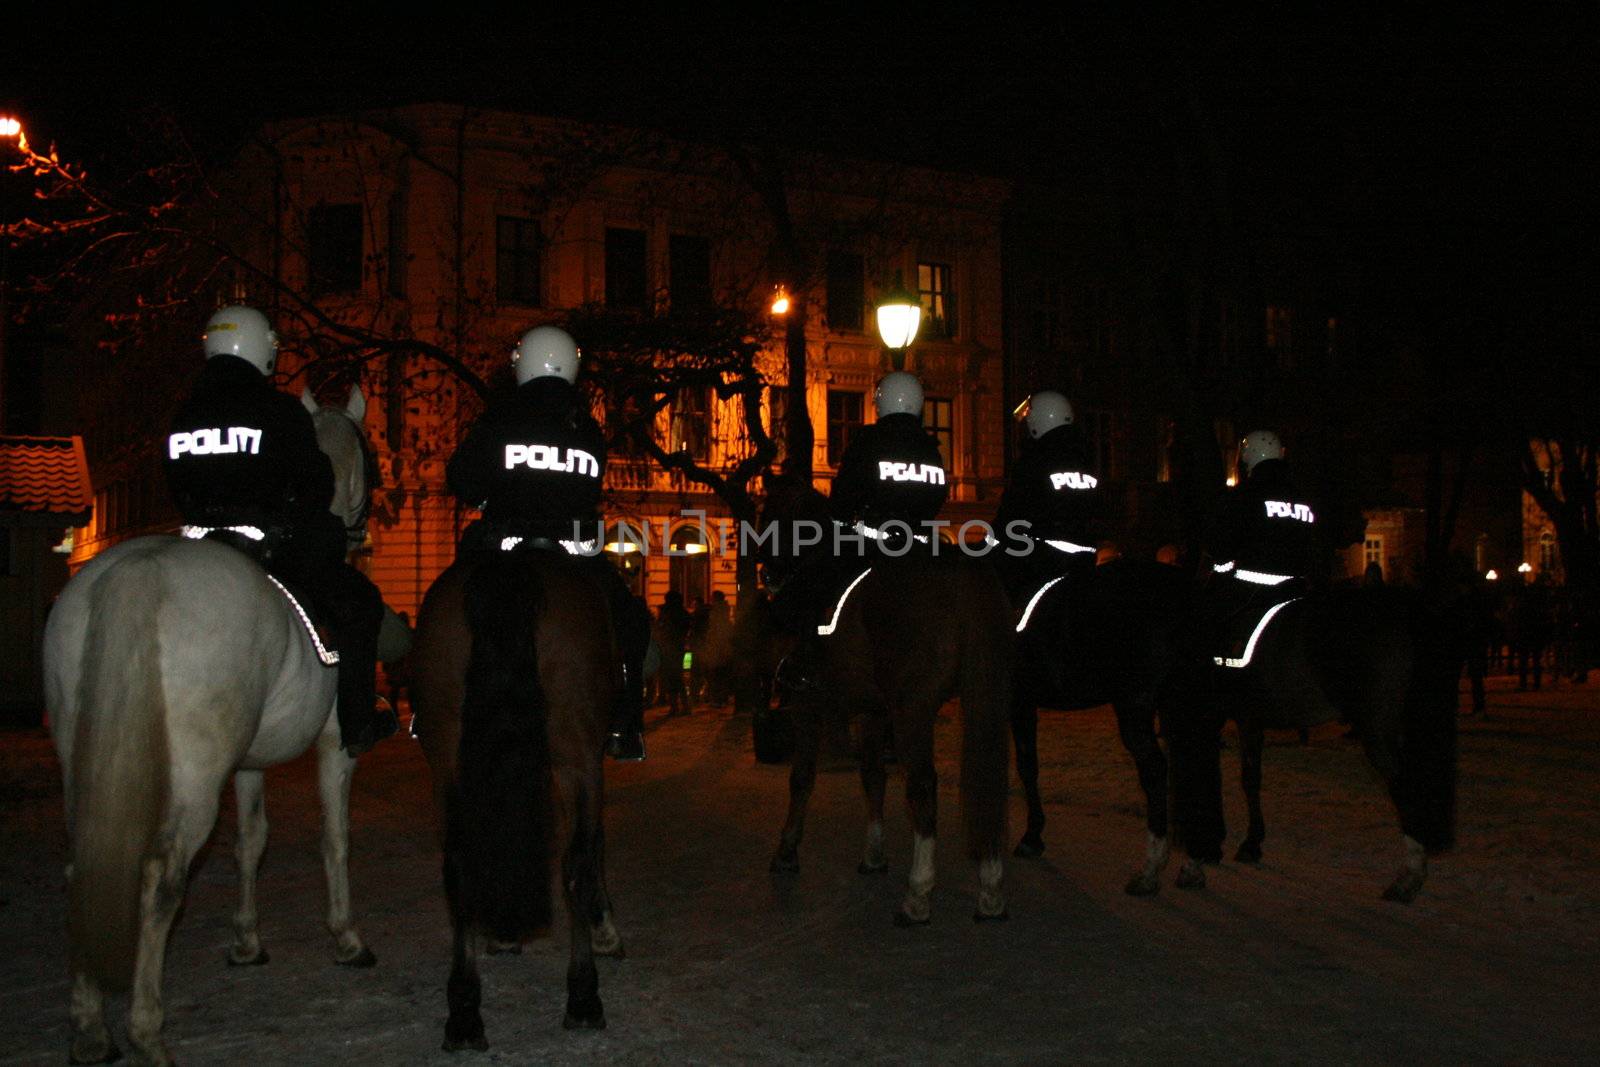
[[829, 413, 950, 533]]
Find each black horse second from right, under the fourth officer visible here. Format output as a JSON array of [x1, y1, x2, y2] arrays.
[[995, 556, 1189, 896]]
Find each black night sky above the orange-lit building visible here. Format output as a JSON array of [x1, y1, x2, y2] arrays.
[[0, 3, 1597, 350]]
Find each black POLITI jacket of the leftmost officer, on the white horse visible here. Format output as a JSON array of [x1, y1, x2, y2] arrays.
[[162, 355, 333, 528]]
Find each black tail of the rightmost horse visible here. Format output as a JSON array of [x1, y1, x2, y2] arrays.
[[1395, 611, 1464, 853]]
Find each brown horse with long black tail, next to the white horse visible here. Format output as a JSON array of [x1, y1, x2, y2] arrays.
[[411, 552, 622, 1051]]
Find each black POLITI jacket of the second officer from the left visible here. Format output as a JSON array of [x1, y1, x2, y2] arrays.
[[445, 378, 605, 537]]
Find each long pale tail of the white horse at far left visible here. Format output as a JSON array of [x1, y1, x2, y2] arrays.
[[67, 555, 171, 990]]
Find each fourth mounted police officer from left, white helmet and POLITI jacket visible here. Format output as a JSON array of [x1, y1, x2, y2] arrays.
[[995, 390, 1102, 607]]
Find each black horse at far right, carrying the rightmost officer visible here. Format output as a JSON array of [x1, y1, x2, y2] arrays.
[[1166, 587, 1462, 901]]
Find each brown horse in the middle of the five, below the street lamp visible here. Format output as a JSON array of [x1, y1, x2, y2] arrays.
[[765, 491, 1011, 925]]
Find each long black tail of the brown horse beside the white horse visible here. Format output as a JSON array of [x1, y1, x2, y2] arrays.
[[445, 557, 552, 941]]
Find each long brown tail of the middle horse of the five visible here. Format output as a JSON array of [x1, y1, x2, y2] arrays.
[[960, 571, 1011, 861]]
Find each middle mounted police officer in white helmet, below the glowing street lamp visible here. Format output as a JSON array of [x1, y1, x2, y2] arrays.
[[778, 371, 950, 693]]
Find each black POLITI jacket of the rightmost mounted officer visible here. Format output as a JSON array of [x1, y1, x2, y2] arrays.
[[1211, 459, 1322, 577]]
